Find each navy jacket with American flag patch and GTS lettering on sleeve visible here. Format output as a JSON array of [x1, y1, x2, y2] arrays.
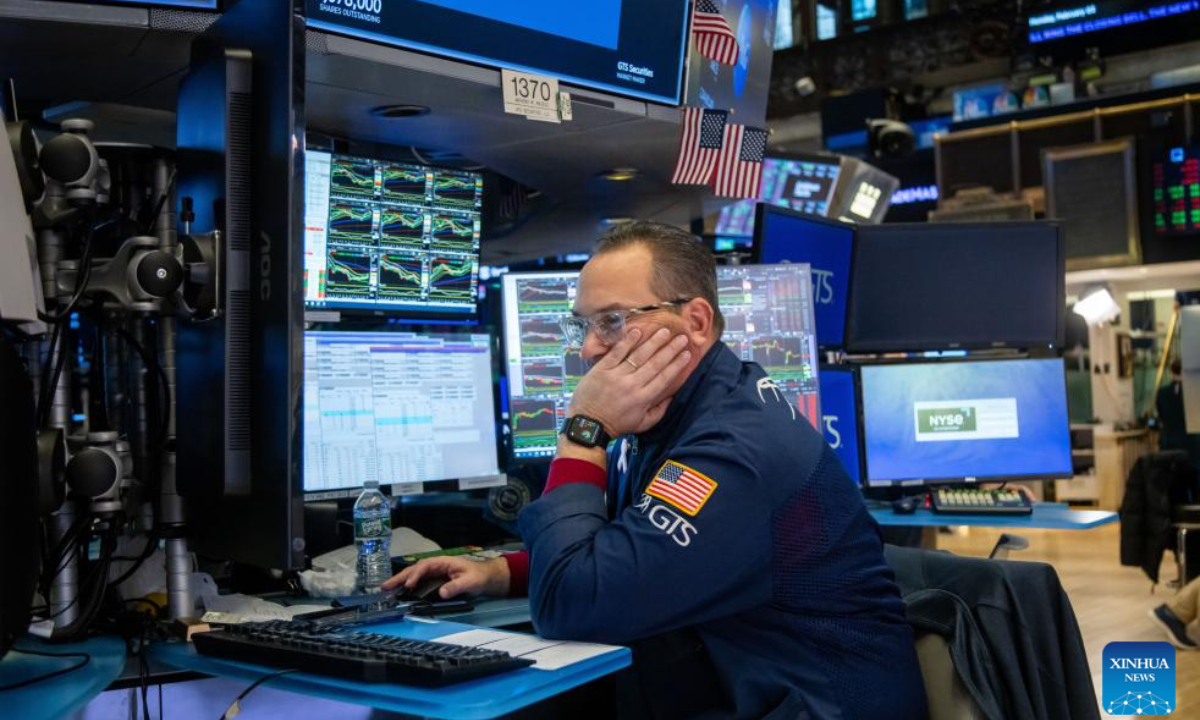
[[520, 343, 926, 720]]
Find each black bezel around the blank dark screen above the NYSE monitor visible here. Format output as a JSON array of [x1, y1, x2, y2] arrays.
[[845, 220, 1067, 353]]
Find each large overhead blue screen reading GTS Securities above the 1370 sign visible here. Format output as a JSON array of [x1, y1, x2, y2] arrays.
[[305, 0, 691, 104]]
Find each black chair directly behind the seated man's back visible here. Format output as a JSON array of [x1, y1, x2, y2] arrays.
[[884, 545, 1100, 720]]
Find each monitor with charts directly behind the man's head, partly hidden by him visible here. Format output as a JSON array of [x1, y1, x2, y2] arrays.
[[503, 264, 821, 460]]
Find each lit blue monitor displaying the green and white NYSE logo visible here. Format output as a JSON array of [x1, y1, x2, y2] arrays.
[[860, 358, 1072, 486]]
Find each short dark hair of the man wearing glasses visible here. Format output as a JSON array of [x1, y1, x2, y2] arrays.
[[595, 222, 725, 340]]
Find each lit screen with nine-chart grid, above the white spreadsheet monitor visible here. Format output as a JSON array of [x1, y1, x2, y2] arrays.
[[304, 150, 484, 317]]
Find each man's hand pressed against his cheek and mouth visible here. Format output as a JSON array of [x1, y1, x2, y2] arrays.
[[568, 328, 691, 437]]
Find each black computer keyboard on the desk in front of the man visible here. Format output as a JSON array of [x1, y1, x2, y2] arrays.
[[193, 620, 533, 686]]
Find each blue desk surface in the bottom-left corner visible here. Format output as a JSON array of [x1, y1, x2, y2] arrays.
[[0, 636, 125, 720]]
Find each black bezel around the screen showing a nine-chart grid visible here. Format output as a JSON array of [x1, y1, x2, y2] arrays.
[[301, 143, 491, 316]]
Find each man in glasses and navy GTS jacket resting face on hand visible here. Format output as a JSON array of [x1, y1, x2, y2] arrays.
[[389, 223, 926, 720]]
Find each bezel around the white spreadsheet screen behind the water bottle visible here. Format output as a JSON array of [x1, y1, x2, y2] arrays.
[[300, 320, 509, 503]]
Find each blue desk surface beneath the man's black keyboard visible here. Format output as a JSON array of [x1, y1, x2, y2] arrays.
[[151, 612, 631, 720]]
